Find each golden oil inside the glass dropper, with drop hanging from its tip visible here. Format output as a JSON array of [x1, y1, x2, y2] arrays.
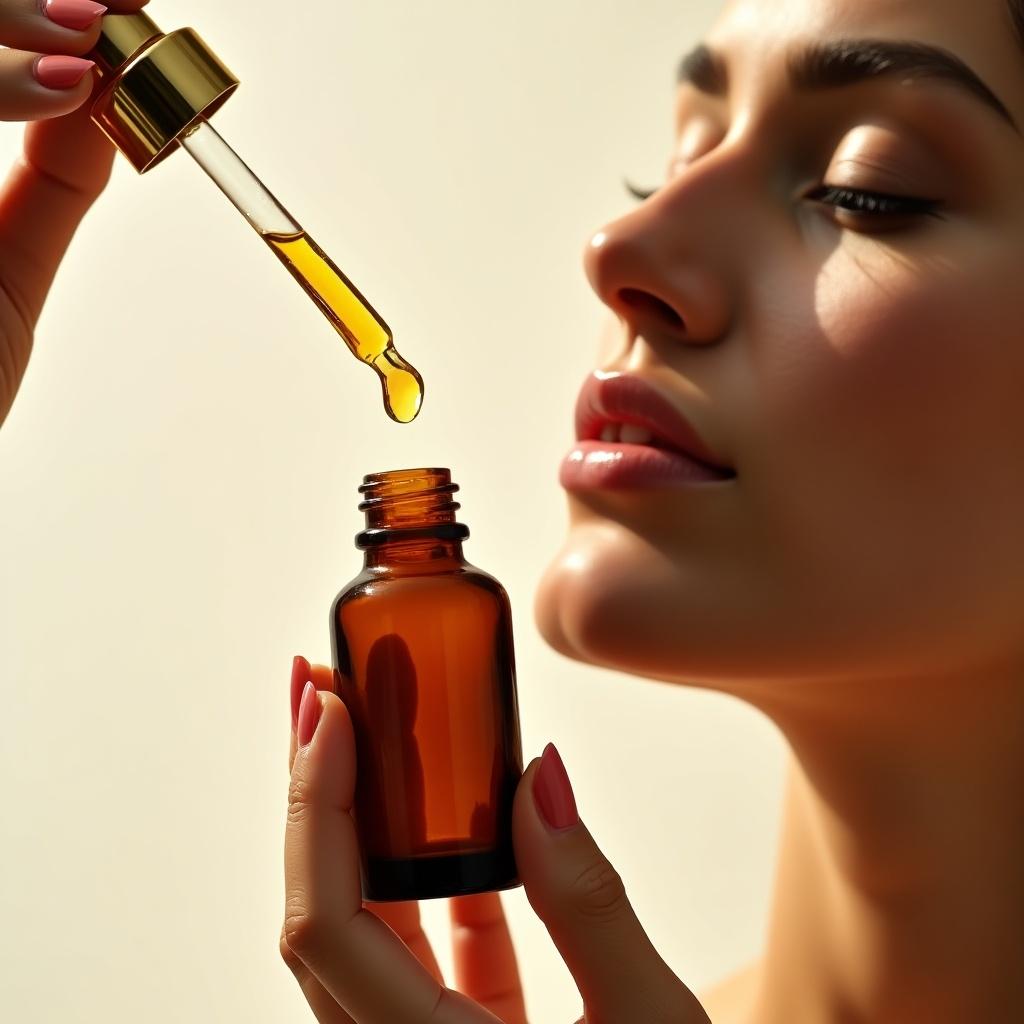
[[263, 231, 423, 423]]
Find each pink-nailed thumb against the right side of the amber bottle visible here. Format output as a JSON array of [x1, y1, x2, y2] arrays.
[[512, 743, 710, 1024]]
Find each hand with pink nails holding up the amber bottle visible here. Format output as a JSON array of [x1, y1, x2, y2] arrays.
[[281, 658, 709, 1024]]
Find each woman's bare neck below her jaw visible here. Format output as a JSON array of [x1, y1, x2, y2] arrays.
[[753, 674, 1024, 1024]]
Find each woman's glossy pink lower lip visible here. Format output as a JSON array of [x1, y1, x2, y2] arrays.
[[559, 441, 735, 490]]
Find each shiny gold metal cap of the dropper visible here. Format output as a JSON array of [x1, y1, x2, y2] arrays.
[[89, 13, 239, 174]]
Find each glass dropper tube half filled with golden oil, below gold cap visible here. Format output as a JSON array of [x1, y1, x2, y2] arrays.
[[181, 119, 423, 423]]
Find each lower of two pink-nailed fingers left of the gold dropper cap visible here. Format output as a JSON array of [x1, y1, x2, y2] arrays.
[[0, 50, 93, 121]]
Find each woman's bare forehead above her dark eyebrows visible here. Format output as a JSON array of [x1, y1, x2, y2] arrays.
[[708, 0, 1024, 96]]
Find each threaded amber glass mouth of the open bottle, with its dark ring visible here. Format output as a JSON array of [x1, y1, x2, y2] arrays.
[[355, 469, 469, 548]]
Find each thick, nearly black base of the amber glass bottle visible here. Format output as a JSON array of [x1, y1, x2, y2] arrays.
[[362, 850, 522, 903]]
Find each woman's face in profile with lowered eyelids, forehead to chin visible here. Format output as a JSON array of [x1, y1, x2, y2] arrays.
[[537, 0, 1024, 687]]
